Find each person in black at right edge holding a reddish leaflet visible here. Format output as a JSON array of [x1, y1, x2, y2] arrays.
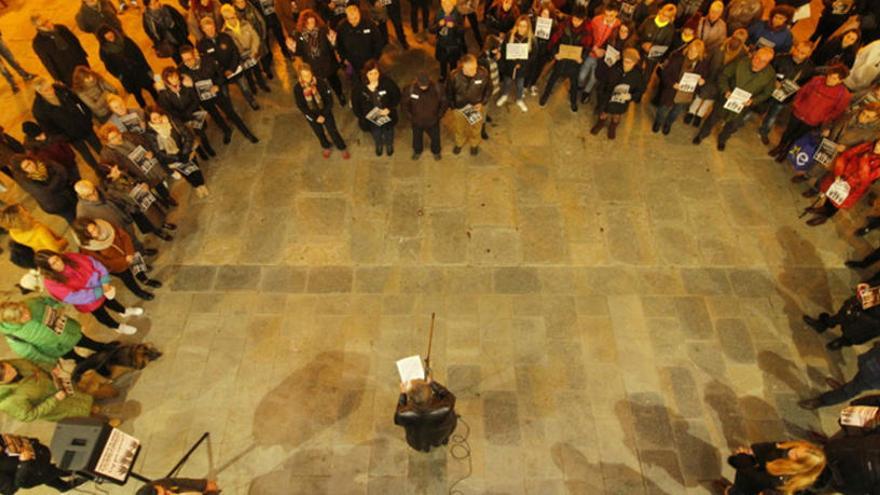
[[803, 276, 880, 351]]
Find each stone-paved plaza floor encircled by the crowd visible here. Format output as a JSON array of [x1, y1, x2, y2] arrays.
[[0, 0, 877, 495]]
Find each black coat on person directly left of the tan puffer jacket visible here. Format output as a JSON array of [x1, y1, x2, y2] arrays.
[[31, 84, 94, 141]]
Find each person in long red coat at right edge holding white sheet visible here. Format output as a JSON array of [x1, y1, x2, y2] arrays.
[[807, 140, 880, 227]]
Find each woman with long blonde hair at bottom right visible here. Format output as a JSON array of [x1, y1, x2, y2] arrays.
[[719, 440, 825, 495]]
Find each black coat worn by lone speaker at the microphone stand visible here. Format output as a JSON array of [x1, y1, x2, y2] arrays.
[[394, 382, 458, 452]]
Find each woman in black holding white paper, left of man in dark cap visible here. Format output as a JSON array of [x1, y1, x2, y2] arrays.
[[351, 60, 400, 156]]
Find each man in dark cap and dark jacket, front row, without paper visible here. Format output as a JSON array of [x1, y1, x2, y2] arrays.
[[400, 72, 447, 160]]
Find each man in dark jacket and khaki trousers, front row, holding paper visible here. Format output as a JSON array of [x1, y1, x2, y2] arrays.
[[446, 54, 492, 155]]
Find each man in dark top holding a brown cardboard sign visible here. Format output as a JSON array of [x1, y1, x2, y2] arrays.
[[538, 5, 593, 112]]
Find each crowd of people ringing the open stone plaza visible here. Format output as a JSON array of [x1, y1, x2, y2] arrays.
[[0, 0, 880, 495]]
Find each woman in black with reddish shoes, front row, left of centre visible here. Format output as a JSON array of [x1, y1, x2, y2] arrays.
[[293, 64, 351, 160]]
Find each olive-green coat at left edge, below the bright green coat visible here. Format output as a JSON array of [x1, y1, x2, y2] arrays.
[[0, 359, 93, 422]]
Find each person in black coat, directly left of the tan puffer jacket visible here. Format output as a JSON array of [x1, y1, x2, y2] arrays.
[[31, 77, 101, 171]]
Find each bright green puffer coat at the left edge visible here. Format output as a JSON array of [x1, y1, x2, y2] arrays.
[[0, 297, 82, 366]]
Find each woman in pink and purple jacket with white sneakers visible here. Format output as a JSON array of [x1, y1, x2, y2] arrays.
[[34, 250, 144, 335]]
